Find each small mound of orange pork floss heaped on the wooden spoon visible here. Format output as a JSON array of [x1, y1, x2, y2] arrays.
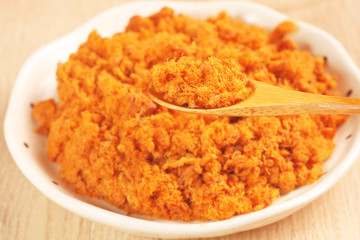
[[152, 56, 252, 108]]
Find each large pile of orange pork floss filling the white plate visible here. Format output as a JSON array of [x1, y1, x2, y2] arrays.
[[33, 8, 345, 221]]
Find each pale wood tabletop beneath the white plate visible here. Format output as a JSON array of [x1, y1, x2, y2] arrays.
[[0, 0, 360, 240]]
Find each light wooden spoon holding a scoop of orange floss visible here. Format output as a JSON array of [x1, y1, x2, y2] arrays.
[[149, 80, 360, 116]]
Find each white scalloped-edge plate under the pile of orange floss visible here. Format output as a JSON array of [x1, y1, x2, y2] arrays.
[[4, 1, 360, 238]]
